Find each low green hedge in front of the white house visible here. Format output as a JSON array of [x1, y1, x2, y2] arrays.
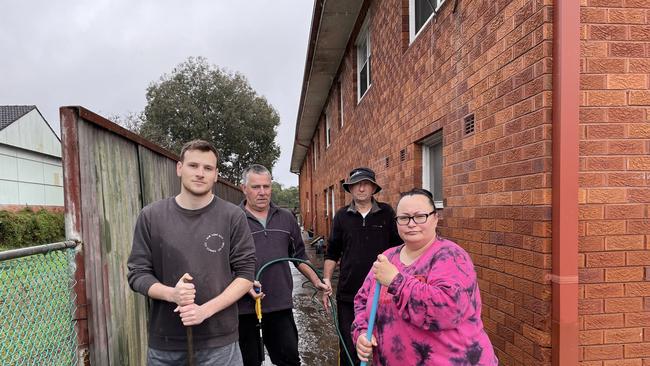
[[0, 208, 65, 250]]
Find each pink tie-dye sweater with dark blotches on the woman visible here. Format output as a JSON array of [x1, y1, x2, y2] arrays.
[[352, 239, 498, 366]]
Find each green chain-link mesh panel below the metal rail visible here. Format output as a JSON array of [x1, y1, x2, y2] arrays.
[[0, 249, 77, 366]]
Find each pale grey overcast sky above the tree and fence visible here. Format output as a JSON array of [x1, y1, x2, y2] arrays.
[[0, 0, 313, 186]]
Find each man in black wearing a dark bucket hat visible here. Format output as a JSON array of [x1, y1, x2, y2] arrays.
[[323, 167, 402, 365]]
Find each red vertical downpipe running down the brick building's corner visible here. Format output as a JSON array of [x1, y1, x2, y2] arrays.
[[551, 1, 580, 365]]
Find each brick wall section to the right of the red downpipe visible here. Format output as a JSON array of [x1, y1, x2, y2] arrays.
[[579, 0, 650, 366]]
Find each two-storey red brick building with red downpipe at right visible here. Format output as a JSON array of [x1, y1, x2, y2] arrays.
[[291, 0, 650, 366]]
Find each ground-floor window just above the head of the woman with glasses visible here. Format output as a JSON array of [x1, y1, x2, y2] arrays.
[[421, 131, 443, 209]]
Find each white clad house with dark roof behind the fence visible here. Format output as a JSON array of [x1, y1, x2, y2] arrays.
[[0, 105, 63, 209]]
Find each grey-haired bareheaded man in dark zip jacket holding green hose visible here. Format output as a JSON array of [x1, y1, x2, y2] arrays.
[[238, 164, 331, 366]]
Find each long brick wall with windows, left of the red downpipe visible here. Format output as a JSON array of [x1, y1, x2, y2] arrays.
[[300, 0, 552, 365]]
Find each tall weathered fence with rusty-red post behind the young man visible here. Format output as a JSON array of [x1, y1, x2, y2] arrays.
[[60, 107, 243, 365]]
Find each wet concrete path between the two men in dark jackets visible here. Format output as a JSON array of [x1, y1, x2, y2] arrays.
[[262, 239, 338, 366]]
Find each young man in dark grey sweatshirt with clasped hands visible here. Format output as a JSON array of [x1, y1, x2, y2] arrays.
[[127, 140, 255, 366]]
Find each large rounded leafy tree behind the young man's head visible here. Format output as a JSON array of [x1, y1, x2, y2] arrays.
[[138, 57, 280, 183]]
